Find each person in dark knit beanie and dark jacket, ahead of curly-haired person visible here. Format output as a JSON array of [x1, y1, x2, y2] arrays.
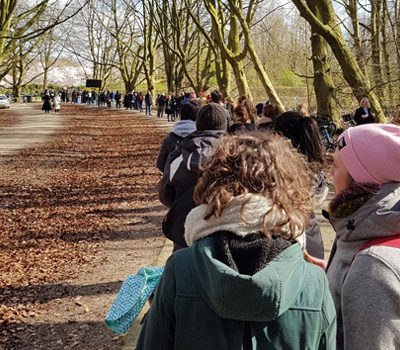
[[158, 102, 226, 251]]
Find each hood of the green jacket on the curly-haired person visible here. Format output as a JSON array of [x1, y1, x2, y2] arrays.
[[191, 236, 309, 322]]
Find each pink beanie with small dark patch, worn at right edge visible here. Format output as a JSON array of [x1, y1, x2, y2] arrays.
[[338, 124, 400, 185]]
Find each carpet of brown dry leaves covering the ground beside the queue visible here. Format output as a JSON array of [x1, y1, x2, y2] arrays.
[[0, 105, 165, 336]]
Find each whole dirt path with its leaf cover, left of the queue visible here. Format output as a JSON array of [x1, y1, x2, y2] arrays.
[[0, 105, 170, 350]]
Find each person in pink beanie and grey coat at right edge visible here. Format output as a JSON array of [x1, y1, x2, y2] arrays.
[[327, 124, 400, 350]]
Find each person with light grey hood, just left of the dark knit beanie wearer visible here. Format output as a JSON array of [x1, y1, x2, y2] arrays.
[[156, 100, 203, 172]]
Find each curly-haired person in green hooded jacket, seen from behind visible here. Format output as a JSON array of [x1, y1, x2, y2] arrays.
[[137, 132, 336, 350]]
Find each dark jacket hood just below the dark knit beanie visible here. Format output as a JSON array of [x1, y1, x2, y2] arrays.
[[180, 130, 225, 171]]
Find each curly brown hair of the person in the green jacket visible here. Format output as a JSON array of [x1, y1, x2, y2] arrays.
[[194, 132, 314, 239]]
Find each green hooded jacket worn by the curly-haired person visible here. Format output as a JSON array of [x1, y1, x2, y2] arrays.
[[137, 236, 336, 350]]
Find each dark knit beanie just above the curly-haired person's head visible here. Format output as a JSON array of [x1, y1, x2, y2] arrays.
[[196, 102, 228, 131]]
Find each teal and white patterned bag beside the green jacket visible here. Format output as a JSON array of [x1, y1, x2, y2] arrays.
[[105, 266, 164, 334]]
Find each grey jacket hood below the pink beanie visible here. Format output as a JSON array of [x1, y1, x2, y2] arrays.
[[330, 182, 400, 242]]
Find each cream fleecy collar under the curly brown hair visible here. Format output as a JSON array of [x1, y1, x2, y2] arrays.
[[185, 194, 305, 247]]
